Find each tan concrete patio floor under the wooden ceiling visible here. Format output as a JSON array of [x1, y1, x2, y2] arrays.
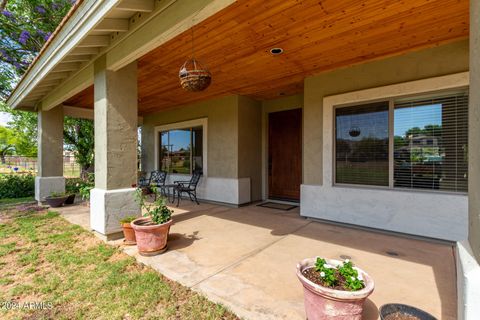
[[60, 201, 457, 320]]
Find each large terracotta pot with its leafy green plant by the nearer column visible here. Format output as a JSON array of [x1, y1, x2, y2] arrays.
[[131, 188, 173, 256]]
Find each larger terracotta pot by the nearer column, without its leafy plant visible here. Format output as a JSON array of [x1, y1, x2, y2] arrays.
[[131, 218, 172, 256]]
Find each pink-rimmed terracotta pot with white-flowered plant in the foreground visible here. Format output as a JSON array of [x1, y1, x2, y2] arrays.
[[297, 257, 374, 320]]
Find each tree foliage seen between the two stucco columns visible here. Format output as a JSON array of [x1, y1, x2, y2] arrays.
[[63, 117, 95, 179]]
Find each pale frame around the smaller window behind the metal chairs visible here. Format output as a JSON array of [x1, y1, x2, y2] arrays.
[[153, 118, 208, 177]]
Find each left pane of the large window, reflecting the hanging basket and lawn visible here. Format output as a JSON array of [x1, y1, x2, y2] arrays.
[[335, 102, 389, 186]]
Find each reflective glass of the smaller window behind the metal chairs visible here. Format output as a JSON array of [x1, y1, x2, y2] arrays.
[[160, 127, 203, 174]]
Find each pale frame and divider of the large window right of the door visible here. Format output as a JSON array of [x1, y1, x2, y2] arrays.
[[323, 72, 469, 194]]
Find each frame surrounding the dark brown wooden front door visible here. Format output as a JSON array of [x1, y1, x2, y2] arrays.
[[262, 105, 304, 204]]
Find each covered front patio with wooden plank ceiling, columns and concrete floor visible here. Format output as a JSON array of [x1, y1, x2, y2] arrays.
[[8, 0, 480, 319]]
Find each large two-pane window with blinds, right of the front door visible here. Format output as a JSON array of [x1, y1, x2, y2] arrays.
[[335, 92, 468, 192]]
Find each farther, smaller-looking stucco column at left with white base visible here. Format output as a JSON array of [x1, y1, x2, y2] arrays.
[[35, 107, 65, 201]]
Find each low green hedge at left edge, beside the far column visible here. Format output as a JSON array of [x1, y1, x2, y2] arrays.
[[0, 174, 35, 199]]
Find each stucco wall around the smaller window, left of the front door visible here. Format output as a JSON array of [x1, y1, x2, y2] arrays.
[[142, 96, 262, 204]]
